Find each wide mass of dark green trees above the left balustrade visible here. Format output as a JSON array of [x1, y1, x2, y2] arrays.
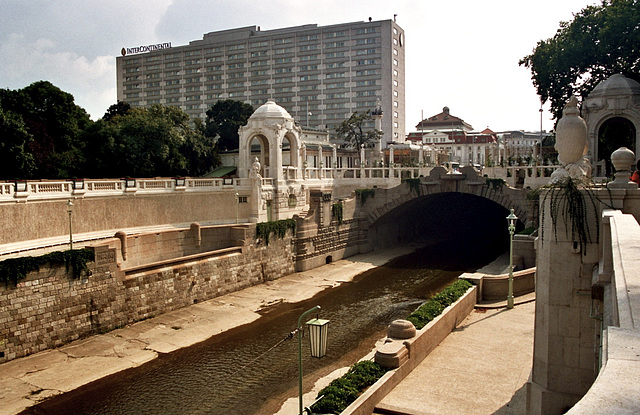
[[0, 81, 219, 179]]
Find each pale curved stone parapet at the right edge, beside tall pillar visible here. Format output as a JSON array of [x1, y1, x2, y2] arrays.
[[567, 210, 640, 415]]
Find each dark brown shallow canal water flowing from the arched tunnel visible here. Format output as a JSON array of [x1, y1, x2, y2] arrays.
[[23, 244, 500, 415]]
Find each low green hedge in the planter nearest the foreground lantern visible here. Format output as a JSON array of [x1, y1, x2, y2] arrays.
[[311, 360, 387, 414]]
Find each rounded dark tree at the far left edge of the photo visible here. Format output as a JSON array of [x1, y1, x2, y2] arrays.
[[0, 107, 35, 180]]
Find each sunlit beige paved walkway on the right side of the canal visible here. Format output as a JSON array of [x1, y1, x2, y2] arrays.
[[374, 302, 535, 415]]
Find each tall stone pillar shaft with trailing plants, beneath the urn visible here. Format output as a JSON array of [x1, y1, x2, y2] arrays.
[[527, 189, 599, 415]]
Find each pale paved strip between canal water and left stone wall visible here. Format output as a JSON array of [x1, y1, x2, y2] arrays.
[[0, 247, 414, 415]]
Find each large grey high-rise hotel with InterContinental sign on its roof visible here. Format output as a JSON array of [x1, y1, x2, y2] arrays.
[[116, 20, 405, 142]]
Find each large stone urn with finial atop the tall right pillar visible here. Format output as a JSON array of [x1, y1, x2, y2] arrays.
[[555, 95, 587, 166]]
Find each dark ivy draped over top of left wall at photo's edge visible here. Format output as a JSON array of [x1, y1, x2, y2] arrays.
[[0, 249, 94, 286]]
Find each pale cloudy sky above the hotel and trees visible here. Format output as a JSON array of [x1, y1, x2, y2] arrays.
[[0, 0, 600, 132]]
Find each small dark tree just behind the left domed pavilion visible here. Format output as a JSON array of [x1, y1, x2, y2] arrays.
[[205, 99, 253, 151]]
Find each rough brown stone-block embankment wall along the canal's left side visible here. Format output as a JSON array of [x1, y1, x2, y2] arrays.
[[0, 228, 295, 363]]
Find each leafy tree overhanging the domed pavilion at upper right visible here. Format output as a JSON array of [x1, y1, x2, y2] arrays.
[[519, 0, 640, 119]]
